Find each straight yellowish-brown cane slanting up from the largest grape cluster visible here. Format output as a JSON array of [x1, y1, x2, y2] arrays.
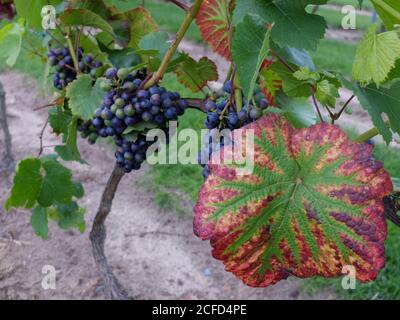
[[145, 0, 203, 89]]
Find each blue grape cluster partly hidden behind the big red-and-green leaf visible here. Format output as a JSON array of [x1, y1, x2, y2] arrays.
[[199, 81, 269, 179]]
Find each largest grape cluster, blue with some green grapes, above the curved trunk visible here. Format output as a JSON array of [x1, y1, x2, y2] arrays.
[[79, 68, 188, 172]]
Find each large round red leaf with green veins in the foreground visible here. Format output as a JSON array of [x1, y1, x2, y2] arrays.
[[194, 115, 393, 287]]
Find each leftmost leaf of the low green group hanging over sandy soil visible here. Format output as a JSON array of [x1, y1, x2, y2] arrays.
[[5, 158, 43, 210]]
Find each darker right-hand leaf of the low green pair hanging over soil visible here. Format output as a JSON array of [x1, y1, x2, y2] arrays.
[[37, 158, 73, 207]]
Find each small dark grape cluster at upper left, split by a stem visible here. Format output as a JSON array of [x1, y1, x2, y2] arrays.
[[47, 47, 103, 90]]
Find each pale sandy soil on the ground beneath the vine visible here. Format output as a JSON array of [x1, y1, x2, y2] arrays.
[[0, 73, 331, 299]]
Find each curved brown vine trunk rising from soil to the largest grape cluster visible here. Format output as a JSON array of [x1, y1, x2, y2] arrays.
[[89, 165, 129, 300]]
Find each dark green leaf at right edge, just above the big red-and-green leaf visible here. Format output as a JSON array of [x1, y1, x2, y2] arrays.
[[342, 78, 400, 144]]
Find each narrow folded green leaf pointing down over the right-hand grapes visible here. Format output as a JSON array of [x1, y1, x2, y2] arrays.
[[232, 15, 271, 102]]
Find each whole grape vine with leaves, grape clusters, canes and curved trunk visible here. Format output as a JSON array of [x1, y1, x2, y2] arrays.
[[0, 0, 400, 299]]
